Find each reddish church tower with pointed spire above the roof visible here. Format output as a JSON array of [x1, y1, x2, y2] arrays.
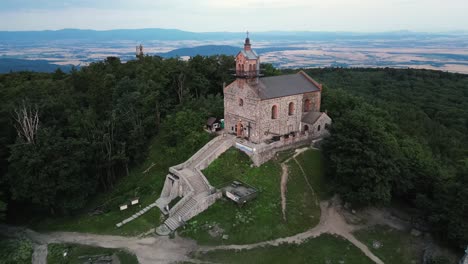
[[236, 32, 260, 79]]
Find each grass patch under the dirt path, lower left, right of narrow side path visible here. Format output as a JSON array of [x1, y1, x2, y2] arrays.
[[47, 244, 138, 264]]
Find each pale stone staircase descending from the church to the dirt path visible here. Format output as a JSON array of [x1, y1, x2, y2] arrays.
[[155, 135, 235, 235]]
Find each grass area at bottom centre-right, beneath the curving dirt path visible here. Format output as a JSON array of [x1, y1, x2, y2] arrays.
[[193, 234, 373, 264]]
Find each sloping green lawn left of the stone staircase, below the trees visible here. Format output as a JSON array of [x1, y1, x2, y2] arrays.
[[32, 132, 211, 236]]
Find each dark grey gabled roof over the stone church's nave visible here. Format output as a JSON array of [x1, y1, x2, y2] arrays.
[[254, 71, 321, 100]]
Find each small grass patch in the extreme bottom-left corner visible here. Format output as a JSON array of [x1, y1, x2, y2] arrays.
[[0, 236, 33, 264]]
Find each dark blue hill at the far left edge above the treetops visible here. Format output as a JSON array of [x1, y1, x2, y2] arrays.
[[0, 57, 72, 73]]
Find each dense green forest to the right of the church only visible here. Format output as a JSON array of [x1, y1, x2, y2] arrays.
[[307, 68, 468, 247]]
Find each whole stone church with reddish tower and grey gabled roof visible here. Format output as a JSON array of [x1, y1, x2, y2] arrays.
[[224, 37, 331, 144]]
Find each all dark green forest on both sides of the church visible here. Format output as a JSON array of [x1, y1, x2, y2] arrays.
[[0, 56, 468, 250]]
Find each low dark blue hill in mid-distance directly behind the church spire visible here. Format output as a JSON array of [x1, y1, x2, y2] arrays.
[[157, 45, 305, 58]]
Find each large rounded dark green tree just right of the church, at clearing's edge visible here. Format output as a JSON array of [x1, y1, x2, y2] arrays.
[[323, 100, 398, 205]]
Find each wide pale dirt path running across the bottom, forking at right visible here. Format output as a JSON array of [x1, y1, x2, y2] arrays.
[[0, 197, 383, 264]]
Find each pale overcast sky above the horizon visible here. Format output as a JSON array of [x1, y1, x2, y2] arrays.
[[0, 0, 468, 32]]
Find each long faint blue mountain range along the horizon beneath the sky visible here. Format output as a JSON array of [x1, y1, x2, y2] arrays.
[[0, 28, 459, 41]]
